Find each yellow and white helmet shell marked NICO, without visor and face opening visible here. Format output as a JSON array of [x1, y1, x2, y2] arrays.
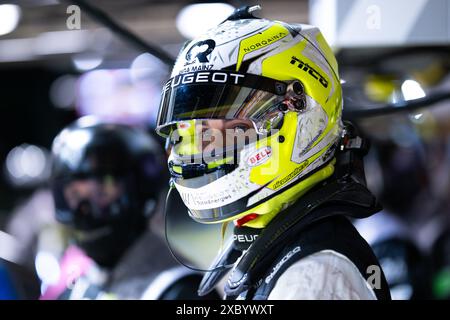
[[160, 18, 342, 227]]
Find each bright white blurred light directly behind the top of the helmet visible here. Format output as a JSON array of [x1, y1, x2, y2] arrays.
[[176, 2, 235, 39]]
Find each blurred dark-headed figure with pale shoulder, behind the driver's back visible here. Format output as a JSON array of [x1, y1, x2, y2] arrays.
[[355, 140, 430, 300]]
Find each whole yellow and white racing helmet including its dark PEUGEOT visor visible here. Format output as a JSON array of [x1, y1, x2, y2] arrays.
[[156, 13, 342, 228]]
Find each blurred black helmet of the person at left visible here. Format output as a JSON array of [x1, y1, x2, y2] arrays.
[[51, 117, 167, 267]]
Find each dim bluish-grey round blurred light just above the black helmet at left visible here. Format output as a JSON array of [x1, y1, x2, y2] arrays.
[[50, 75, 77, 109]]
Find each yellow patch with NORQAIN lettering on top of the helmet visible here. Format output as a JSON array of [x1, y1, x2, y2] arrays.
[[236, 23, 289, 71]]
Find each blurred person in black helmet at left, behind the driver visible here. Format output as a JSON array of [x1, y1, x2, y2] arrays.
[[38, 117, 219, 299]]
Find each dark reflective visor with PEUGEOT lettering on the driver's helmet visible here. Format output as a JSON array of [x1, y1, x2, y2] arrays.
[[156, 71, 287, 137]]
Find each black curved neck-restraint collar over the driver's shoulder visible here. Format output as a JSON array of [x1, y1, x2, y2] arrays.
[[199, 176, 381, 295]]
